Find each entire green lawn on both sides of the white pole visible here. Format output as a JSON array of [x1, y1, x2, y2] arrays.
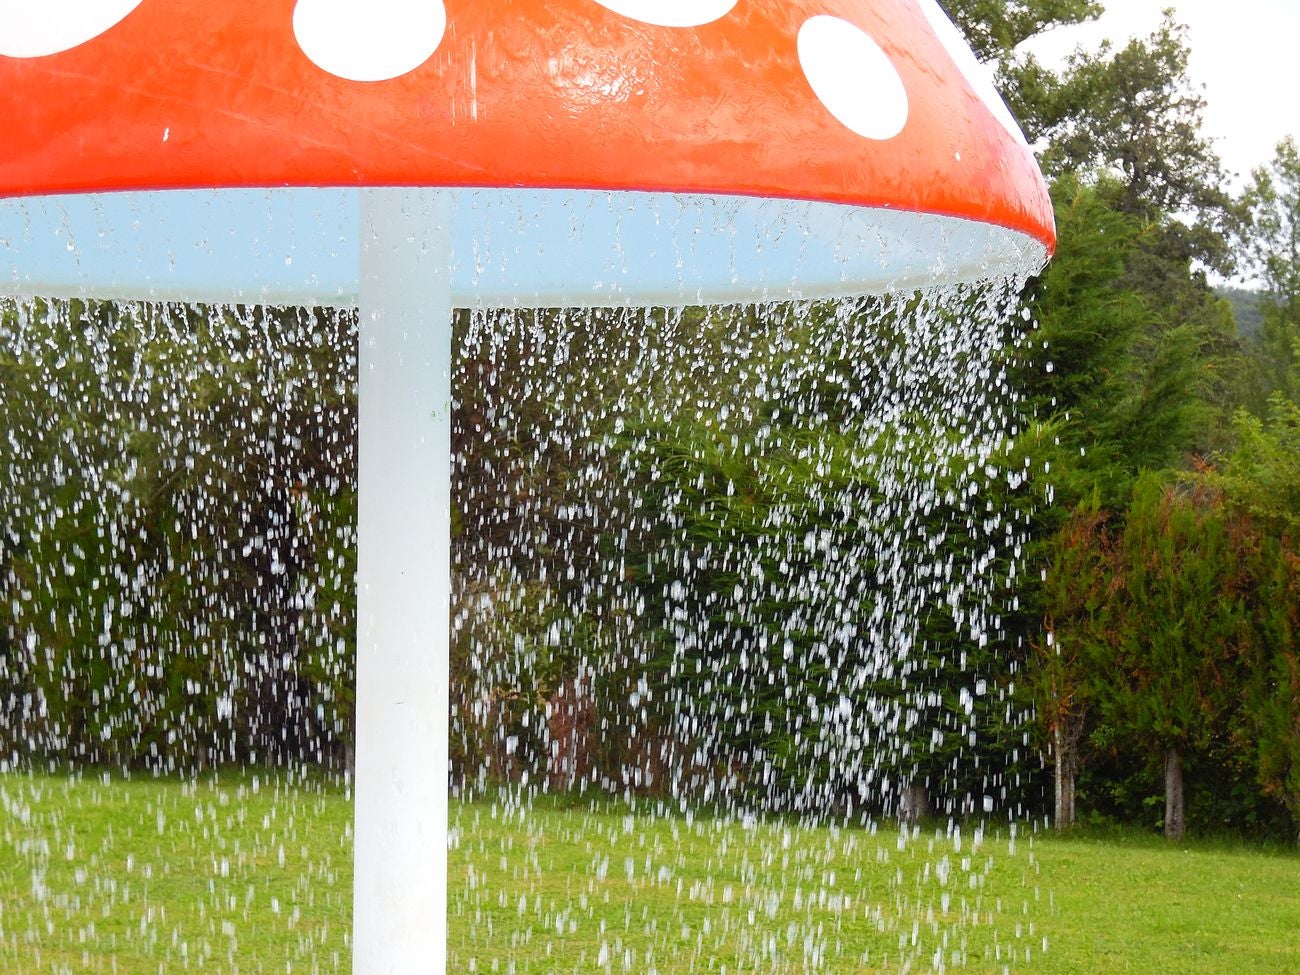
[[0, 774, 1300, 975]]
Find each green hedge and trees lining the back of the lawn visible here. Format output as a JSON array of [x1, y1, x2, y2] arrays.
[[0, 0, 1300, 847]]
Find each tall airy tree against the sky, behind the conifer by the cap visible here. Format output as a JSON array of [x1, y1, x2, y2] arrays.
[[1037, 16, 1247, 444]]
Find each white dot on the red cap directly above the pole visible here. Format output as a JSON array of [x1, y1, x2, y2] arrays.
[[294, 0, 447, 82]]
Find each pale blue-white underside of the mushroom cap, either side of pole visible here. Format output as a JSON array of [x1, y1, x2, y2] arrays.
[[0, 189, 1045, 307]]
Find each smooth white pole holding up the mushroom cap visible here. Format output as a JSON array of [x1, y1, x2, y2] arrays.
[[352, 189, 451, 975]]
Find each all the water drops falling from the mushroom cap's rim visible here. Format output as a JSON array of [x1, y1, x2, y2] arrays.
[[0, 269, 1045, 975]]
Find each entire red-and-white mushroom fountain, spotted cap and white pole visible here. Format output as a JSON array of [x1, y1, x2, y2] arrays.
[[0, 0, 1054, 972]]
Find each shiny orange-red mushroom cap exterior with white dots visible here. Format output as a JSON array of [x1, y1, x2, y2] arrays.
[[0, 0, 1056, 251]]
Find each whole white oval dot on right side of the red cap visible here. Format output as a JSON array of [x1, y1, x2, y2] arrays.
[[798, 14, 907, 140]]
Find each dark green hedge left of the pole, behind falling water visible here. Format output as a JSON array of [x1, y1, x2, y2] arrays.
[[0, 302, 355, 768]]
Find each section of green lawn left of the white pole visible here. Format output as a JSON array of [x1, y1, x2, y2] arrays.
[[0, 774, 352, 975]]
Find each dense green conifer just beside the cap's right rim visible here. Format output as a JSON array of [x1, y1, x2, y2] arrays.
[[1019, 177, 1223, 512]]
